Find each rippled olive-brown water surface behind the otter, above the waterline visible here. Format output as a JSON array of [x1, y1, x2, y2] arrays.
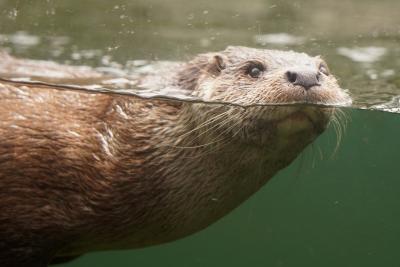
[[0, 0, 400, 112]]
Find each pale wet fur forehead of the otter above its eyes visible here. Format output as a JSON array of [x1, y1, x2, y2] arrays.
[[223, 46, 321, 70]]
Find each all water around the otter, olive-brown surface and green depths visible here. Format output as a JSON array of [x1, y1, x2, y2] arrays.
[[0, 0, 400, 267]]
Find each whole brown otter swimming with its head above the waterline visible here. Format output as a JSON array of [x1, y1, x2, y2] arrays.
[[0, 47, 351, 267]]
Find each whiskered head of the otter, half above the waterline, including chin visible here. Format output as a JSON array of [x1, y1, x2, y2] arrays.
[[178, 47, 351, 149]]
